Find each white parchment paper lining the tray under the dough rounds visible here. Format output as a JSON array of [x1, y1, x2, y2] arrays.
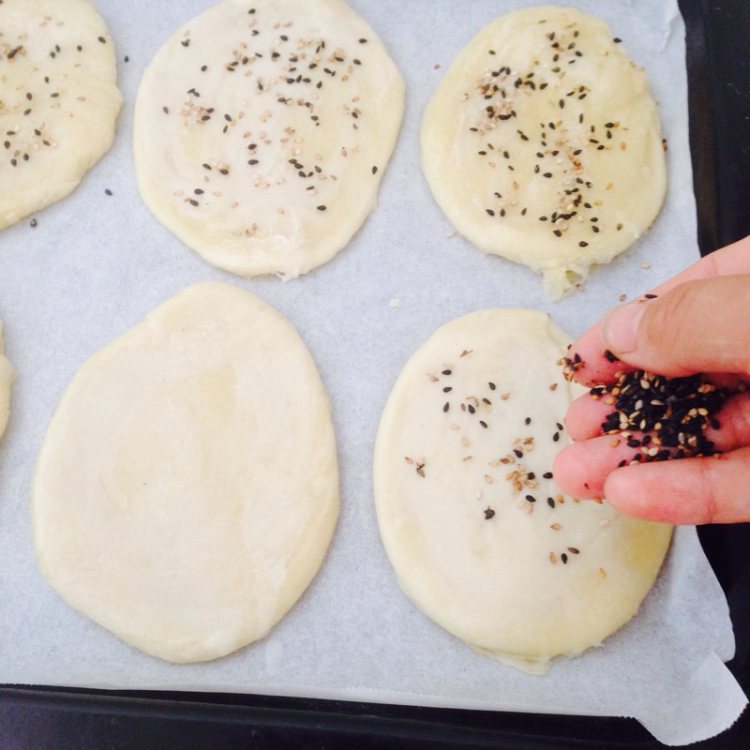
[[0, 0, 746, 744]]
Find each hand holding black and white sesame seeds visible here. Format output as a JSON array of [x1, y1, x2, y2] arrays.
[[553, 237, 750, 524]]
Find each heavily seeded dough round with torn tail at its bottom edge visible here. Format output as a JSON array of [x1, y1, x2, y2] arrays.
[[422, 6, 667, 298]]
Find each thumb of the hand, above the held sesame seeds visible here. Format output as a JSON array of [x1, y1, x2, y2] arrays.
[[602, 274, 750, 376]]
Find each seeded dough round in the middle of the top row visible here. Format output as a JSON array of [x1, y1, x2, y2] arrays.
[[135, 0, 404, 277]]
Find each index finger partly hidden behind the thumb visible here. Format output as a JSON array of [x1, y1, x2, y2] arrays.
[[571, 237, 750, 386]]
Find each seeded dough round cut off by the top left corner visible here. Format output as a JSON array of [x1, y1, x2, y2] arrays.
[[0, 0, 122, 228]]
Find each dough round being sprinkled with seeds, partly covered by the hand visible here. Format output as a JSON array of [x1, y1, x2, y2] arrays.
[[374, 309, 672, 672]]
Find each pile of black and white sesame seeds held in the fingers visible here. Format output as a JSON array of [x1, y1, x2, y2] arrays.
[[590, 370, 730, 466]]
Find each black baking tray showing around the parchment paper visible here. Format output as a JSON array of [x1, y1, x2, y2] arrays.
[[0, 0, 750, 750]]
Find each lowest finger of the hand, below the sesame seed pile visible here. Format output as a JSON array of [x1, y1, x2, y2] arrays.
[[604, 447, 750, 524]]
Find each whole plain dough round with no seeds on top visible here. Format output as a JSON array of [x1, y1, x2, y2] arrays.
[[32, 283, 338, 662]]
